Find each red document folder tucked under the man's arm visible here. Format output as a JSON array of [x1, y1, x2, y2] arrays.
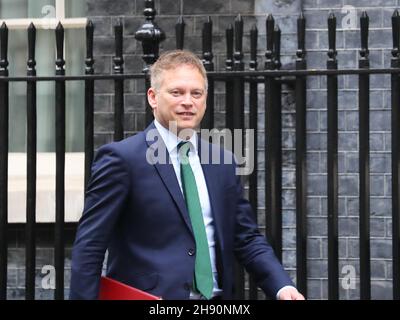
[[99, 277, 161, 300]]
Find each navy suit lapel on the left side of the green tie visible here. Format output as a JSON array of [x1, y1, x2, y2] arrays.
[[144, 123, 193, 234]]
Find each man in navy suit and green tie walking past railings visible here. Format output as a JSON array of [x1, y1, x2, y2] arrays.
[[70, 50, 304, 300]]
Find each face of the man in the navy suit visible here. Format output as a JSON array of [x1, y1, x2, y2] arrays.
[[147, 65, 207, 134]]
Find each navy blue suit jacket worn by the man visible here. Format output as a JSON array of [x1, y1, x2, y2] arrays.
[[70, 124, 293, 299]]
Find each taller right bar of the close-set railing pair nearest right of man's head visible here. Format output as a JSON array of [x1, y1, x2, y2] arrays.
[[232, 14, 245, 300]]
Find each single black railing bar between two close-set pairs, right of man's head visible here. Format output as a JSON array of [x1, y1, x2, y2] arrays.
[[249, 25, 258, 300]]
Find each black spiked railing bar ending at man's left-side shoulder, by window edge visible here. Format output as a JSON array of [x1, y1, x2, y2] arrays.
[[85, 20, 94, 190]]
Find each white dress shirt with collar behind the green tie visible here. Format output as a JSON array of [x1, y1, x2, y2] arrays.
[[154, 120, 222, 299]]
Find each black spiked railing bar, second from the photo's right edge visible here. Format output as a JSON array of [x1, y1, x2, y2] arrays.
[[358, 11, 371, 300]]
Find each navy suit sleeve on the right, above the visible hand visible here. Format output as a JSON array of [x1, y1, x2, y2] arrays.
[[234, 166, 294, 299]]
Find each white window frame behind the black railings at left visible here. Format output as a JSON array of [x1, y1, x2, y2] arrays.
[[0, 0, 88, 223]]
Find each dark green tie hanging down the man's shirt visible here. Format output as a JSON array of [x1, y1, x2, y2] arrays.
[[178, 141, 213, 299]]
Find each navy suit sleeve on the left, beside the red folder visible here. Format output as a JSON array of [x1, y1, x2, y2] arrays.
[[70, 144, 130, 299]]
